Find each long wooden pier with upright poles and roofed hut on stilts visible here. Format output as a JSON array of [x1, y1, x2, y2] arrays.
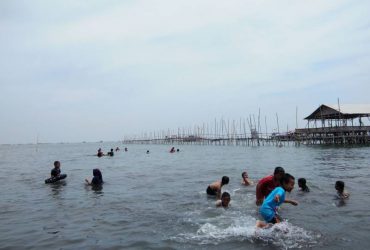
[[123, 105, 370, 147]]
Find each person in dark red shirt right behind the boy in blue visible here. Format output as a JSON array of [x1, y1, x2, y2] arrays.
[[256, 167, 285, 206]]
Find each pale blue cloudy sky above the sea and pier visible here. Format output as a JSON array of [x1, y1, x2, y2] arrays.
[[0, 0, 370, 143]]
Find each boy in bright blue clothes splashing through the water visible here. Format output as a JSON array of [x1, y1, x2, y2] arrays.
[[256, 173, 298, 228]]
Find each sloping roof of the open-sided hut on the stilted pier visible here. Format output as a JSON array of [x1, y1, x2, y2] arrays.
[[304, 104, 370, 120]]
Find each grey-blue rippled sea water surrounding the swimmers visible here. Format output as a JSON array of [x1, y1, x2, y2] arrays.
[[0, 142, 370, 250]]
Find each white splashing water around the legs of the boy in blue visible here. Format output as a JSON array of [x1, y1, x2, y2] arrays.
[[171, 216, 321, 249]]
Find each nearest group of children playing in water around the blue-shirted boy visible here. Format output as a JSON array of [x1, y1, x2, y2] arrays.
[[206, 167, 349, 228]]
